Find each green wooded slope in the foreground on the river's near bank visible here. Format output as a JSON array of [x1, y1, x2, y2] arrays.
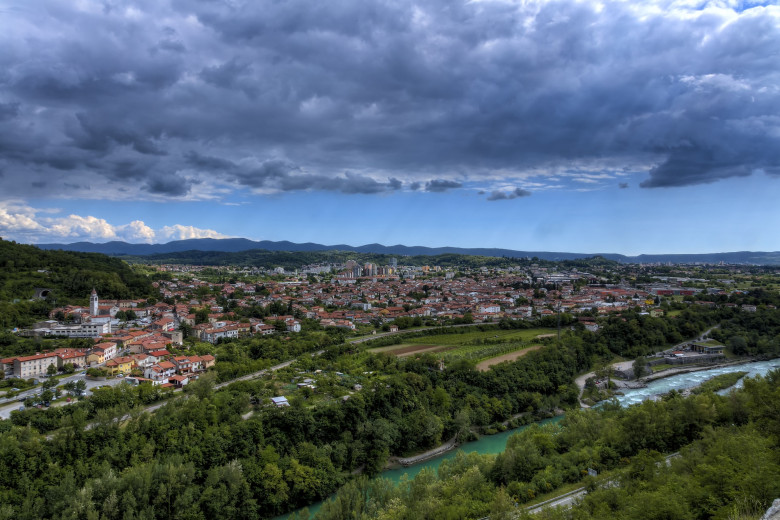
[[316, 370, 780, 520]]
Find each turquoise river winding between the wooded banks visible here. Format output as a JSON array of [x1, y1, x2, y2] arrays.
[[274, 359, 780, 520]]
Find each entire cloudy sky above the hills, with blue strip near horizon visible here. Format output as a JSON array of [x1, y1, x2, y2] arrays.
[[0, 0, 780, 254]]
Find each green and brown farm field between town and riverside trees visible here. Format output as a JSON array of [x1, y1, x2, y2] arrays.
[[368, 328, 555, 370]]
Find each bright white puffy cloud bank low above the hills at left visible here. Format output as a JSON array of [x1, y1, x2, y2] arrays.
[[0, 200, 228, 244]]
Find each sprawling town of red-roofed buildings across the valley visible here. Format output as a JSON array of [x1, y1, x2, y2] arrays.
[[0, 258, 768, 388]]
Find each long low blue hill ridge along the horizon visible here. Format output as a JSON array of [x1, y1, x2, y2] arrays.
[[38, 238, 780, 265]]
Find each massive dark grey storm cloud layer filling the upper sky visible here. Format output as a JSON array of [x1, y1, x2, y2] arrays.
[[0, 0, 780, 200]]
